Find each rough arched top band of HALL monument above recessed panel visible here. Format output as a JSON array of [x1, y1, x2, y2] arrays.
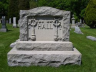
[[20, 6, 70, 18]]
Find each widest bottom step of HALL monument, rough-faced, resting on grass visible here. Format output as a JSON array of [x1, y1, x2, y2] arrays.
[[7, 47, 81, 67]]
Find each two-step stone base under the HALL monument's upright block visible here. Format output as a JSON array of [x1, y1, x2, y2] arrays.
[[7, 41, 81, 67]]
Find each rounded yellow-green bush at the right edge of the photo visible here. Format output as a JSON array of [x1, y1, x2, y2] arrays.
[[85, 0, 96, 28]]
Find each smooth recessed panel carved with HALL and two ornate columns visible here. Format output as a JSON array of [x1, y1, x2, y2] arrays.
[[28, 16, 62, 41]]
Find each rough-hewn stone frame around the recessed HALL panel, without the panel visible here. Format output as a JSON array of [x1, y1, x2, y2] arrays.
[[19, 7, 70, 41]]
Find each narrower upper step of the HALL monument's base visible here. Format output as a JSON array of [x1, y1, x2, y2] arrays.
[[16, 41, 73, 51]]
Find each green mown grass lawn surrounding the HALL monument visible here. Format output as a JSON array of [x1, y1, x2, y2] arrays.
[[0, 24, 96, 72]]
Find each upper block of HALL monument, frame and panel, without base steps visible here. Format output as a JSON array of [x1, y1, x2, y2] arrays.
[[19, 7, 70, 41]]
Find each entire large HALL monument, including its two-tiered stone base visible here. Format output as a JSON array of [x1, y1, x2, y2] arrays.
[[7, 7, 81, 67]]
